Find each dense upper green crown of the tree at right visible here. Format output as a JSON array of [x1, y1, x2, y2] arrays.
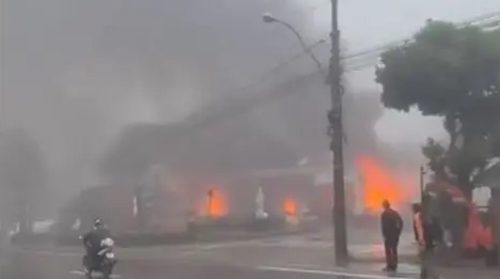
[[377, 22, 500, 116]]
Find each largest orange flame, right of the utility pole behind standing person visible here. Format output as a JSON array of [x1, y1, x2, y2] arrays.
[[357, 156, 408, 213]]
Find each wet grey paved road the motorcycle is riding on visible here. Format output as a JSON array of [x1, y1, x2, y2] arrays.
[[1, 232, 415, 279]]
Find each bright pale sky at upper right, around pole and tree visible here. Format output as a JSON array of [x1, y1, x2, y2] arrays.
[[295, 0, 500, 144]]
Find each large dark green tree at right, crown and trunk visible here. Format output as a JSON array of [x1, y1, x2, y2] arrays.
[[376, 21, 500, 196]]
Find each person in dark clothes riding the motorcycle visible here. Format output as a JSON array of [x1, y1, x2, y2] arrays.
[[82, 218, 110, 269]]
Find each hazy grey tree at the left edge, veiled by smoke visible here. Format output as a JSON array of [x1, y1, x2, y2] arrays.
[[0, 130, 48, 232]]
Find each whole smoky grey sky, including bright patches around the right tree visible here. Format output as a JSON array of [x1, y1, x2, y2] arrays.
[[1, 0, 500, 202]]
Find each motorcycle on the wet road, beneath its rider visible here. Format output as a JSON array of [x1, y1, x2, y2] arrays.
[[83, 237, 117, 279]]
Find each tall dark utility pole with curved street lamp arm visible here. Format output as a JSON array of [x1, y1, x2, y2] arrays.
[[328, 0, 348, 265]]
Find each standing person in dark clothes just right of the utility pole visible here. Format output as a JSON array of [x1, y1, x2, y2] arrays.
[[381, 200, 403, 271]]
